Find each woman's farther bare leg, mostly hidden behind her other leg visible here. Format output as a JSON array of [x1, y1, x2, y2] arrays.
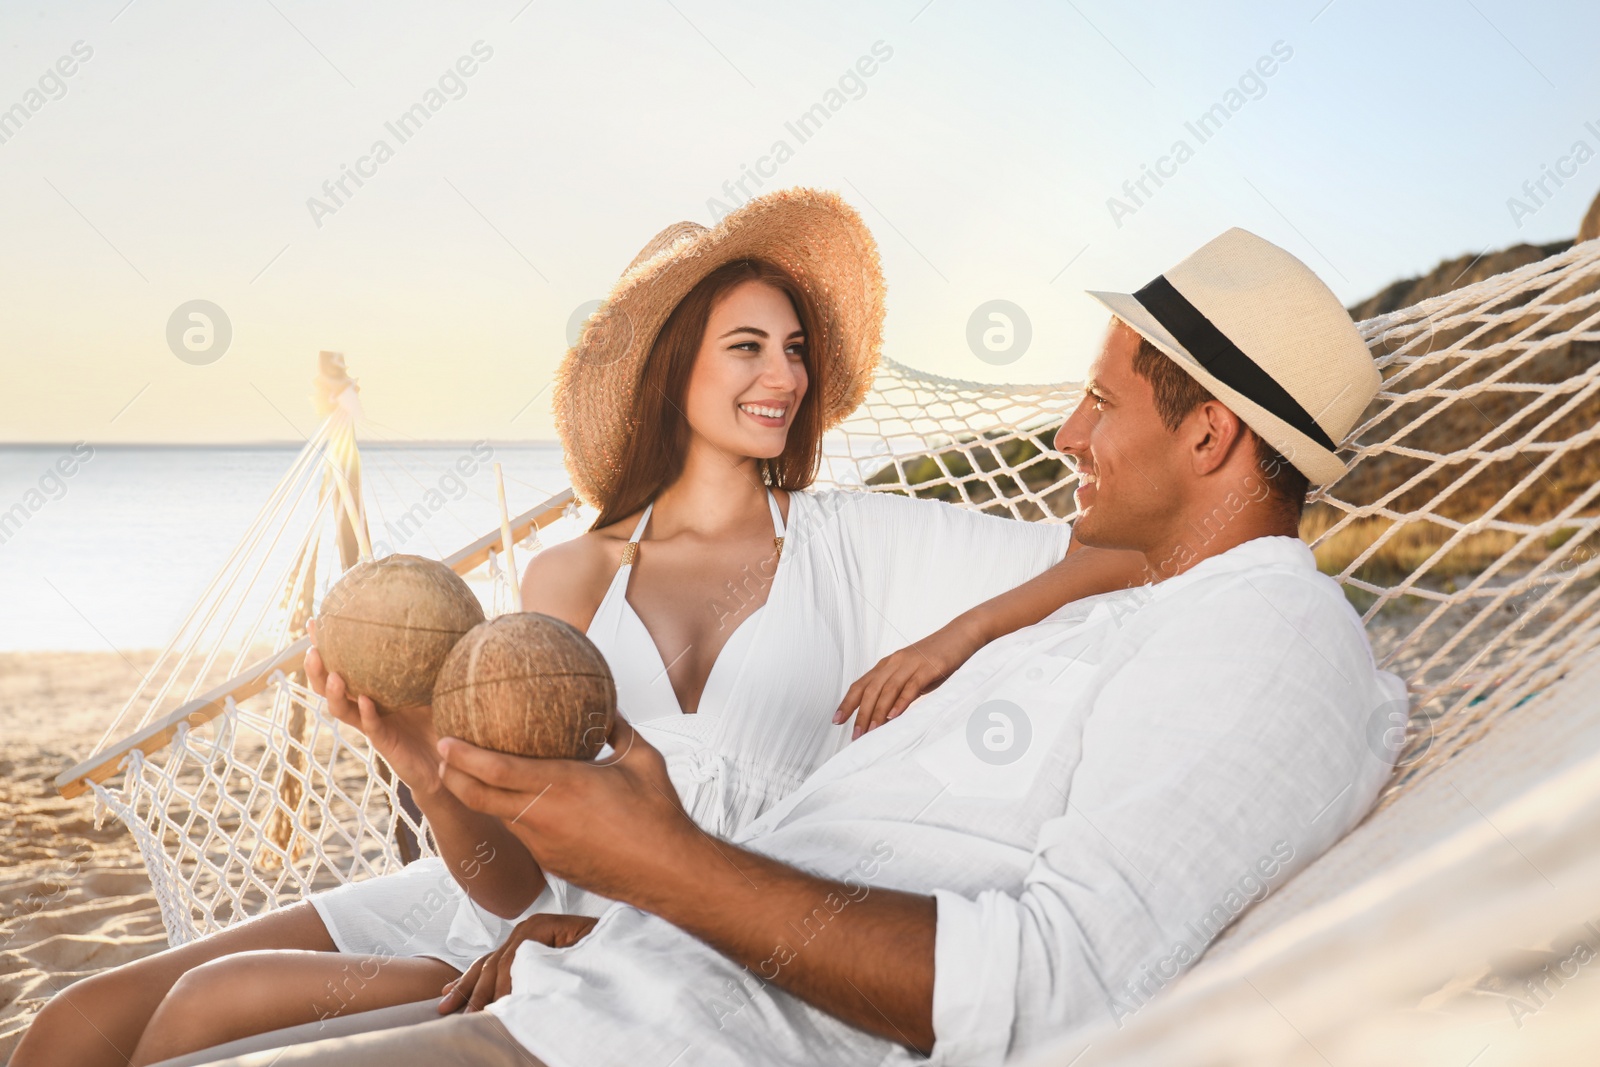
[[11, 902, 337, 1067]]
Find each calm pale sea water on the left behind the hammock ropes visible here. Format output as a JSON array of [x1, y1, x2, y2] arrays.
[[0, 442, 568, 649]]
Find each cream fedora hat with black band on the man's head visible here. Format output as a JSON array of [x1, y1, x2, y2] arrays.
[[1090, 227, 1382, 485]]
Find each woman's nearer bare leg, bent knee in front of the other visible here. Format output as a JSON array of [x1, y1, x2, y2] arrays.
[[133, 950, 461, 1067]]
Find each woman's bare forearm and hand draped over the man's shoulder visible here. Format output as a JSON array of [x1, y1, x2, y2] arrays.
[[834, 541, 1149, 739]]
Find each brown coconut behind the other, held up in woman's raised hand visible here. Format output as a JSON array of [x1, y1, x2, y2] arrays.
[[317, 555, 483, 710]]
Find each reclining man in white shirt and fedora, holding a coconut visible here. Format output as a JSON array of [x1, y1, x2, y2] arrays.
[[193, 229, 1405, 1067]]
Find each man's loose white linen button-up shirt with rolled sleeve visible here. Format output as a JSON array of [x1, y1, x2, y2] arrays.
[[490, 537, 1405, 1067]]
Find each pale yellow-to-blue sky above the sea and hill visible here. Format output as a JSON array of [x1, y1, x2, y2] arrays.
[[0, 0, 1600, 443]]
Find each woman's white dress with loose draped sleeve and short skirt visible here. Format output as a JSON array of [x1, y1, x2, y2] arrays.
[[310, 491, 1069, 971]]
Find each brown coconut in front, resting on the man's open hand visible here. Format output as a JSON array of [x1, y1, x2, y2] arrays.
[[434, 611, 616, 760]]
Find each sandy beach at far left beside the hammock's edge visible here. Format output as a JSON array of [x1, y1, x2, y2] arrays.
[[0, 651, 166, 1061]]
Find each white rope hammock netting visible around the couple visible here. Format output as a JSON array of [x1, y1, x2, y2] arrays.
[[61, 242, 1600, 944]]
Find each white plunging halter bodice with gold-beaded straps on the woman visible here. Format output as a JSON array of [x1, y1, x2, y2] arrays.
[[589, 490, 784, 726]]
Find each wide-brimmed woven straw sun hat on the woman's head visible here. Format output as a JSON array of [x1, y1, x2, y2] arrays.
[[554, 189, 883, 506]]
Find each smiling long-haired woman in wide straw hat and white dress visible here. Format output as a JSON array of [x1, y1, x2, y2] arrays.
[[13, 190, 1138, 1067]]
